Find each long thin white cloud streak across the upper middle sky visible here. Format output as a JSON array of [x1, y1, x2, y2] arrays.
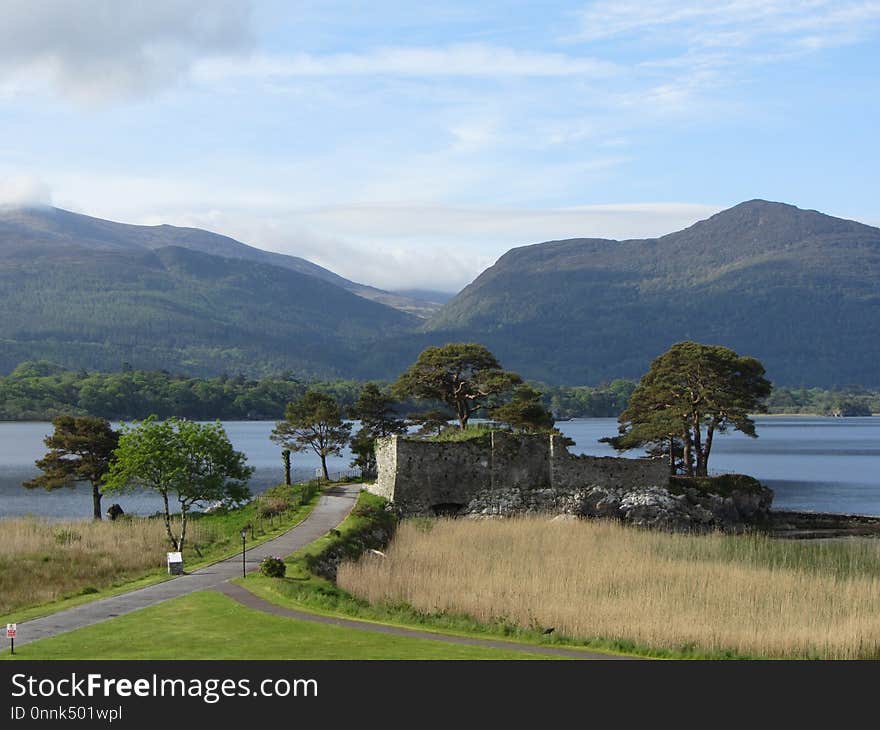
[[193, 43, 617, 82]]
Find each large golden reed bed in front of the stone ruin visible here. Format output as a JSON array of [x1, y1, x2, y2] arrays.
[[338, 517, 880, 659]]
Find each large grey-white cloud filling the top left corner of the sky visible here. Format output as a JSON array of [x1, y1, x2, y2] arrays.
[[0, 0, 251, 101]]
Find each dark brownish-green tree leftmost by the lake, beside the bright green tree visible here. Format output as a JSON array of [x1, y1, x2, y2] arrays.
[[24, 416, 119, 520]]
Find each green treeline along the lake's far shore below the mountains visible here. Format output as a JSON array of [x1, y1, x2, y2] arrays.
[[0, 361, 880, 421]]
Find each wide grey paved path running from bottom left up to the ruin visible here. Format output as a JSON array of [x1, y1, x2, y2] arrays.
[[15, 484, 361, 646]]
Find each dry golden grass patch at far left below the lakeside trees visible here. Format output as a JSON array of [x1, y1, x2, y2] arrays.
[[0, 518, 210, 616]]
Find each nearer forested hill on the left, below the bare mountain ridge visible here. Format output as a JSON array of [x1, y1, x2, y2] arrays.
[[0, 244, 417, 376]]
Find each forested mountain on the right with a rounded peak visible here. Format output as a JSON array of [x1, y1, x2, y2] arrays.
[[427, 201, 880, 386]]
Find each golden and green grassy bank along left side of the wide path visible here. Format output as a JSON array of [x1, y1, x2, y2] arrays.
[[0, 478, 316, 621]]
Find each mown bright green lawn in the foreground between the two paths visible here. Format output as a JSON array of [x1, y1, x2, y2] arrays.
[[0, 591, 555, 660]]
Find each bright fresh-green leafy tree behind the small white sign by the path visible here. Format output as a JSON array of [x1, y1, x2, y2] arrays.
[[104, 417, 253, 550]]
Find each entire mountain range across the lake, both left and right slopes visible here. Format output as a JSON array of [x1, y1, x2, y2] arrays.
[[0, 200, 880, 387]]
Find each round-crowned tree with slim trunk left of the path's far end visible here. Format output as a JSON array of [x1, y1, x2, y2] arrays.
[[270, 389, 351, 479]]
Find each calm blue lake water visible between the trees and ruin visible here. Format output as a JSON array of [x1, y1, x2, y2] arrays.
[[0, 417, 880, 518]]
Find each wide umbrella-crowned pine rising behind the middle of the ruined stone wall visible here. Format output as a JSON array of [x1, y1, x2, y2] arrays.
[[394, 342, 522, 428]]
